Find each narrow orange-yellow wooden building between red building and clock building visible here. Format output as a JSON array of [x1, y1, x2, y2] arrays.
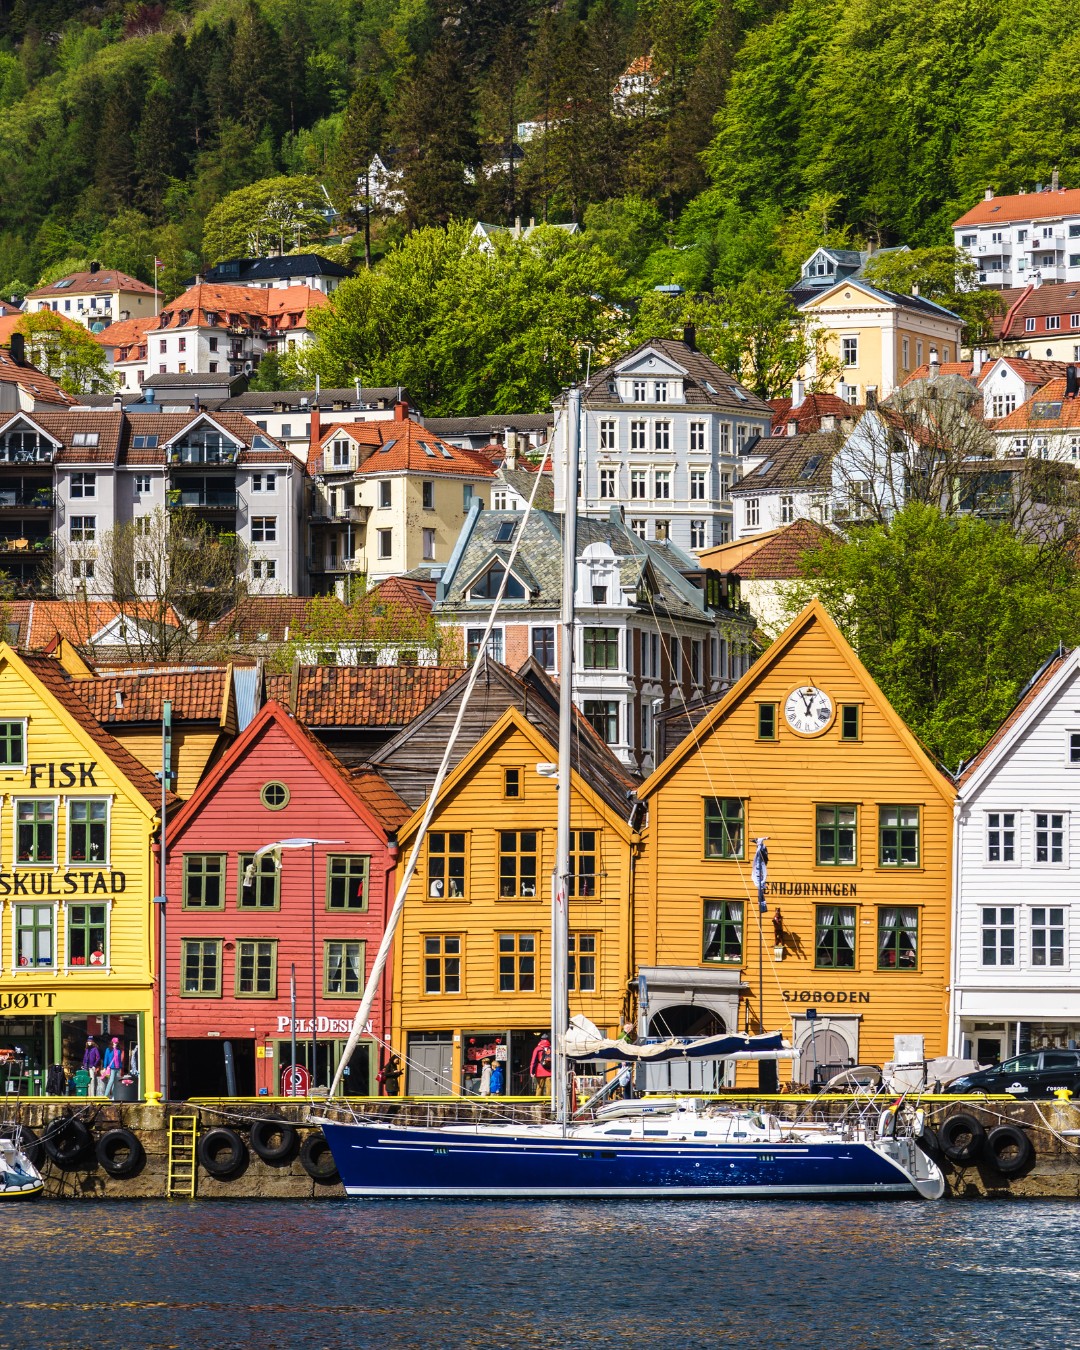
[[392, 706, 639, 1095]]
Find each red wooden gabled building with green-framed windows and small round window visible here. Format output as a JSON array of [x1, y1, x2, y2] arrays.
[[158, 701, 412, 1098]]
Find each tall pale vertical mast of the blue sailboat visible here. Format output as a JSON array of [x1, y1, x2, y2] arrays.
[[551, 389, 582, 1125]]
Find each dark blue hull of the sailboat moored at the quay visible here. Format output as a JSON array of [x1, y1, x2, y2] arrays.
[[323, 1122, 917, 1200]]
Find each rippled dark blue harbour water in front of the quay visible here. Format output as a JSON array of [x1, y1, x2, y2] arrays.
[[0, 1202, 1080, 1350]]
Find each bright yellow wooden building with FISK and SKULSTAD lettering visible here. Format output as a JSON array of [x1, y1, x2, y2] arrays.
[[0, 643, 161, 1095]]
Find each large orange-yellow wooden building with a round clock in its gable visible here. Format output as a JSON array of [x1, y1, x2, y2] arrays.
[[635, 601, 954, 1085]]
